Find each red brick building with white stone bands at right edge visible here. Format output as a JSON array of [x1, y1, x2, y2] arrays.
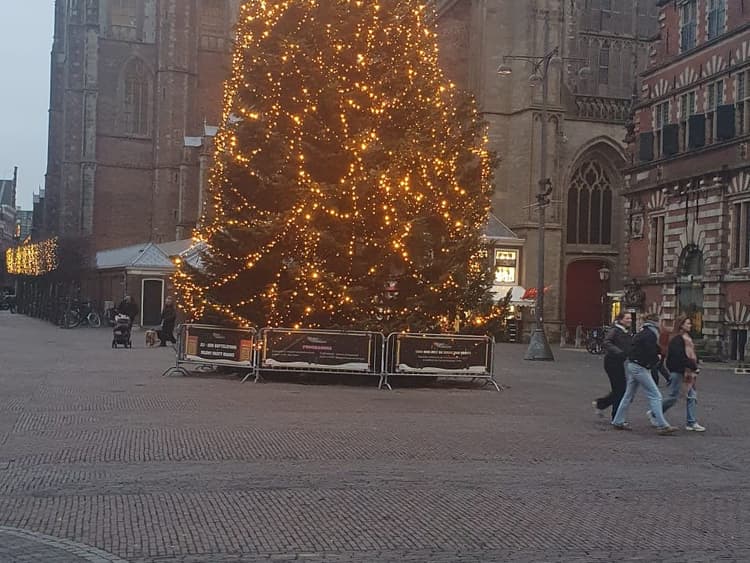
[[626, 0, 750, 358]]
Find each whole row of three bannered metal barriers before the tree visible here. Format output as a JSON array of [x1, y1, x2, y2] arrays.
[[162, 324, 500, 391]]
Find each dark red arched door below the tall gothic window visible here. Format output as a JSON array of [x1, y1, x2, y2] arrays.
[[565, 260, 608, 334]]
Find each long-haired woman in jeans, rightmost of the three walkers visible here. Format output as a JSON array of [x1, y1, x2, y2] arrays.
[[646, 316, 706, 432]]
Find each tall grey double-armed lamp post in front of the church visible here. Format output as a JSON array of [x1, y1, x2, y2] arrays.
[[497, 14, 590, 361]]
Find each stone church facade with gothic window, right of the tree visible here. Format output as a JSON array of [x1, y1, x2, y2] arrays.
[[435, 0, 658, 338]]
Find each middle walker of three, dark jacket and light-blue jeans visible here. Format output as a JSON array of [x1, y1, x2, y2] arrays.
[[612, 314, 677, 435]]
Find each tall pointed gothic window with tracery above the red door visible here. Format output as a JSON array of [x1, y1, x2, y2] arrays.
[[567, 160, 612, 244]]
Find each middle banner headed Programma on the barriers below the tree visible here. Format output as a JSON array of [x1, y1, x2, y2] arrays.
[[259, 329, 380, 372]]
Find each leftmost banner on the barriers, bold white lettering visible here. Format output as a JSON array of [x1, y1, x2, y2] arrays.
[[184, 325, 254, 368]]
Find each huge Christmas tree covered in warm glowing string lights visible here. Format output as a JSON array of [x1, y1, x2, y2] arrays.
[[175, 0, 491, 330]]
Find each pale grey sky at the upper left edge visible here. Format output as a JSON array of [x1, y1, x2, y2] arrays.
[[0, 0, 55, 209]]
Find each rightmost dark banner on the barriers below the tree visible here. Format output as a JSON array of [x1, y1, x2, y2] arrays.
[[395, 334, 490, 375]]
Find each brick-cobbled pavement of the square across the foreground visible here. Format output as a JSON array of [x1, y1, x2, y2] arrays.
[[0, 313, 750, 563]]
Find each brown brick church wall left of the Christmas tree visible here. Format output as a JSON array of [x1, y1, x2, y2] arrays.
[[40, 0, 240, 249]]
